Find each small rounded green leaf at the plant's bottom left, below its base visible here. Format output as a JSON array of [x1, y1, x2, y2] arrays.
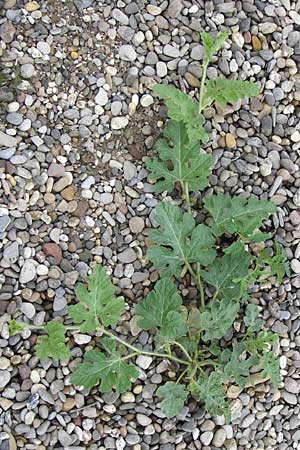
[[156, 381, 188, 417]]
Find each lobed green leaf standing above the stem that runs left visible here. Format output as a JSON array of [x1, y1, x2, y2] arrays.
[[68, 265, 124, 333]]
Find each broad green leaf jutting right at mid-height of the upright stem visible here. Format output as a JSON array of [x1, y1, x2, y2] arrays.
[[204, 194, 276, 237]]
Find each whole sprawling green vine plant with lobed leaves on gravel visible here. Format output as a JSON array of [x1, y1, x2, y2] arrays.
[[10, 33, 288, 417]]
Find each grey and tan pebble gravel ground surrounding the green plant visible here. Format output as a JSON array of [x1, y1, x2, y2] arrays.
[[0, 0, 300, 450]]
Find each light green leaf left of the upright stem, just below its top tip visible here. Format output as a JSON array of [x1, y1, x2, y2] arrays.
[[152, 84, 208, 143]]
